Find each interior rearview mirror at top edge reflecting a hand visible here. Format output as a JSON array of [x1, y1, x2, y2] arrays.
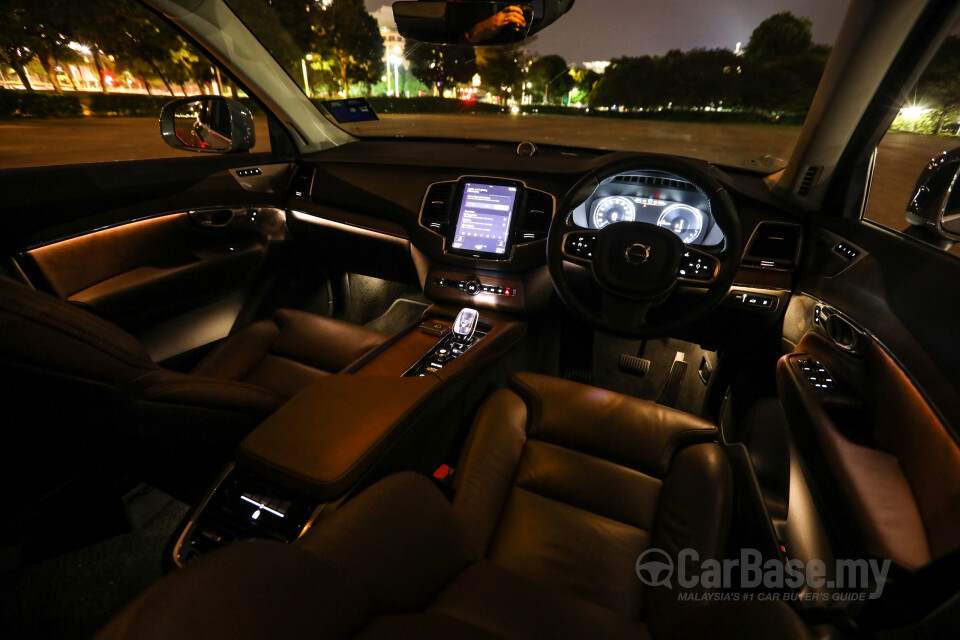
[[393, 0, 574, 45]]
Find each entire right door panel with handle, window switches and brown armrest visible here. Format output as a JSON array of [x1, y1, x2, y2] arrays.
[[777, 220, 960, 569]]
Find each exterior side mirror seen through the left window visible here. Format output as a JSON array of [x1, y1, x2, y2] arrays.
[[160, 96, 256, 153]]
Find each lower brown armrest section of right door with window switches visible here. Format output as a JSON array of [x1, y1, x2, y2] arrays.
[[777, 320, 960, 569]]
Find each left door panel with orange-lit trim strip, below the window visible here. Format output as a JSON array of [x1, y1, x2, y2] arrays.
[[0, 154, 291, 357]]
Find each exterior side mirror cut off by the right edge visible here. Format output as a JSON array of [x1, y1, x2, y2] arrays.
[[907, 148, 960, 243]]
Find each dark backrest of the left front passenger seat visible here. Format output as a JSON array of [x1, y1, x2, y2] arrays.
[[0, 278, 270, 503]]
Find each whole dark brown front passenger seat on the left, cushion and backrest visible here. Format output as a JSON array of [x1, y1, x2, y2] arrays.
[[0, 278, 388, 493]]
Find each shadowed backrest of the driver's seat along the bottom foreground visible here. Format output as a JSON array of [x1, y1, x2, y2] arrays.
[[97, 473, 808, 640]]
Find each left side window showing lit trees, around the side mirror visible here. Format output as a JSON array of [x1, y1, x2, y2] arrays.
[[0, 0, 270, 169]]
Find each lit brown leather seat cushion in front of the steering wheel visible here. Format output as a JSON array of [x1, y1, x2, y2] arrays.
[[454, 373, 732, 619]]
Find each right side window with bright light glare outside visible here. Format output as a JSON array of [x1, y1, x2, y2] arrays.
[[864, 27, 960, 256]]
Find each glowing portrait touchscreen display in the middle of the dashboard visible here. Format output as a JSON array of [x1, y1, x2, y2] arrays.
[[451, 182, 517, 255]]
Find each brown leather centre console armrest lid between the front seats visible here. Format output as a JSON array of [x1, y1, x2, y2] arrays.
[[240, 375, 440, 500]]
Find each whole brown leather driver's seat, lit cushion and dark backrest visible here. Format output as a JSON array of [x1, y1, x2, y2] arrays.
[[98, 374, 808, 640]]
